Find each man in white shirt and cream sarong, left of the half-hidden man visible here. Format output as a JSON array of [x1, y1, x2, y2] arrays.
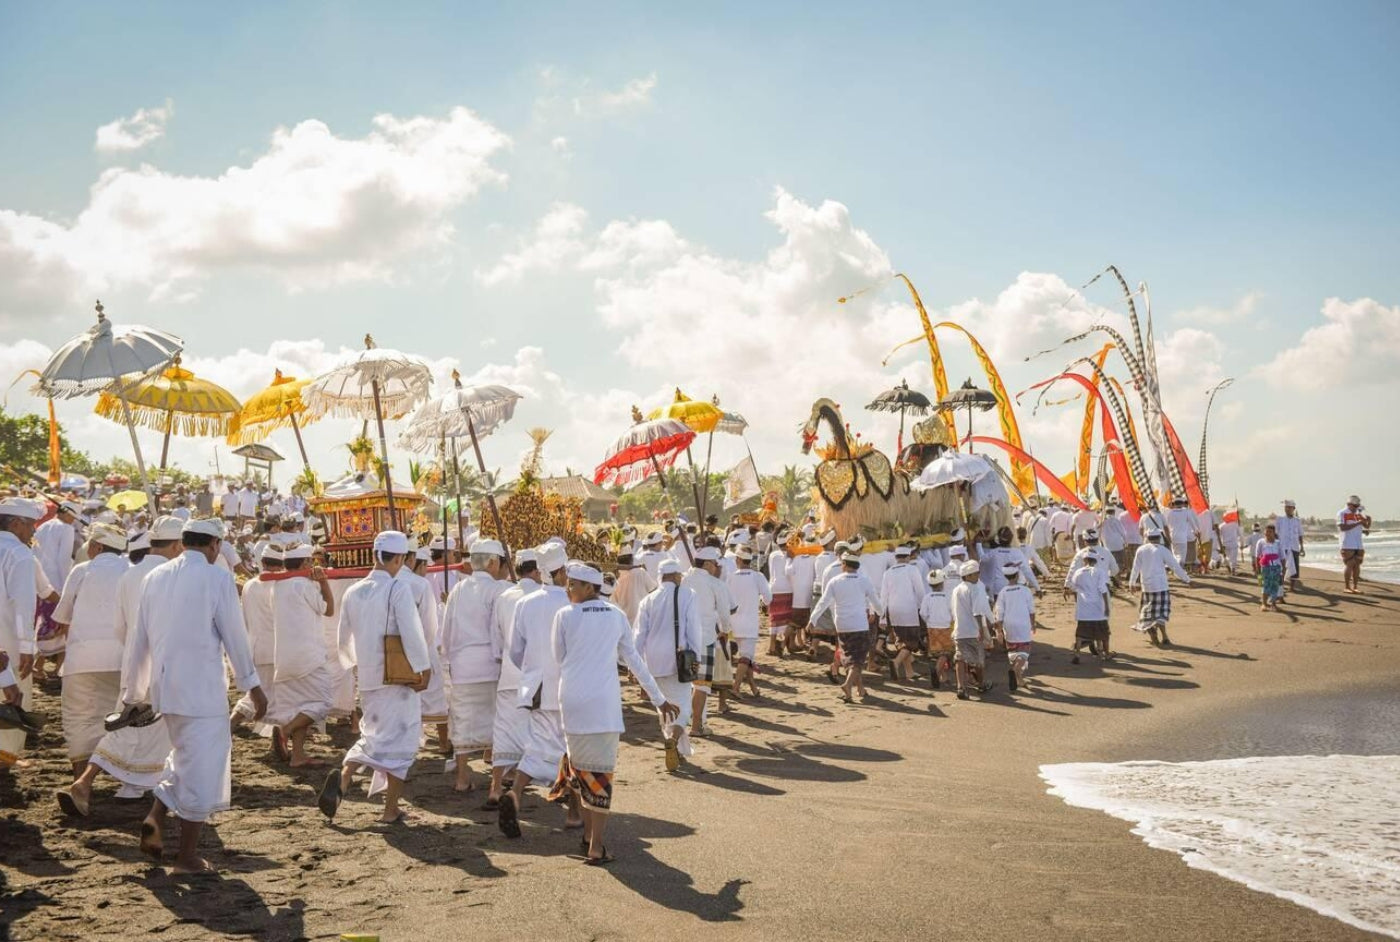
[[53, 523, 130, 780]]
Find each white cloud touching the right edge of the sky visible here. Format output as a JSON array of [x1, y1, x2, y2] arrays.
[[1257, 298, 1400, 391]]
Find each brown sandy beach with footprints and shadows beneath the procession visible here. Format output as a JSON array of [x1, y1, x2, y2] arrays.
[[0, 562, 1400, 942]]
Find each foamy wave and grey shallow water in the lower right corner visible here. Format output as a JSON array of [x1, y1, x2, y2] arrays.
[[1040, 689, 1400, 939]]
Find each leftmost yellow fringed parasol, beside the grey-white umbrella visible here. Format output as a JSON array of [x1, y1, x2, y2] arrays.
[[92, 354, 241, 470]]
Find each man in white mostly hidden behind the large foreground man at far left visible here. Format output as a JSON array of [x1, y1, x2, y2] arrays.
[[57, 516, 183, 817]]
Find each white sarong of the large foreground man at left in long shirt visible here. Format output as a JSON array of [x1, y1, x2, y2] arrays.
[[154, 712, 234, 822]]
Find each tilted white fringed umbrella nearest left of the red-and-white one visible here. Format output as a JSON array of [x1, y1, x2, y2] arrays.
[[399, 370, 521, 550]]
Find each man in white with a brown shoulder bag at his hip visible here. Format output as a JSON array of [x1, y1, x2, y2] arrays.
[[316, 530, 431, 824]]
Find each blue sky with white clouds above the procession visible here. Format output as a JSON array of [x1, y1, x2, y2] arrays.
[[0, 3, 1400, 518]]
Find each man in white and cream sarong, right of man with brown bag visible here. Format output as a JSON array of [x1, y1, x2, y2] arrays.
[[442, 540, 510, 792]]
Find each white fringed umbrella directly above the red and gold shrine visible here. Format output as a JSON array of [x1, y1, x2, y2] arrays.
[[301, 335, 433, 525]]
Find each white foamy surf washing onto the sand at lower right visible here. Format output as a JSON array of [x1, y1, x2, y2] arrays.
[[1040, 756, 1400, 939]]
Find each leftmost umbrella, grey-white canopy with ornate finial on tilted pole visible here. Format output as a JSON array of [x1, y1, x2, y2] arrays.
[[35, 301, 185, 494]]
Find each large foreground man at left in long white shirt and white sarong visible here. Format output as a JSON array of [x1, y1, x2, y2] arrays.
[[122, 519, 267, 872]]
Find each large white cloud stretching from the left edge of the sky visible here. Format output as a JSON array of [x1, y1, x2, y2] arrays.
[[0, 108, 510, 321]]
